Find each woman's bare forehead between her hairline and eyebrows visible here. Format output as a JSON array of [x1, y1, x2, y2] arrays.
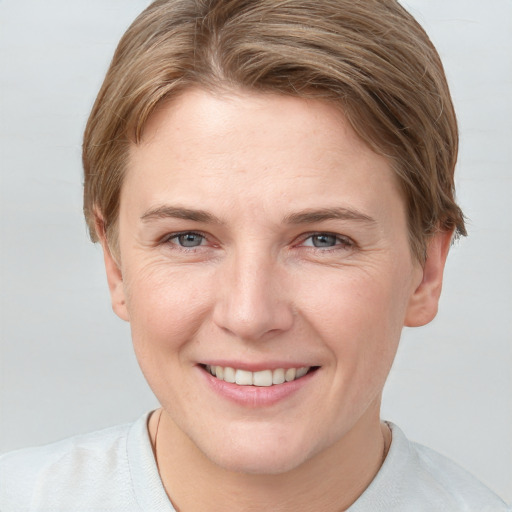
[[121, 89, 401, 222]]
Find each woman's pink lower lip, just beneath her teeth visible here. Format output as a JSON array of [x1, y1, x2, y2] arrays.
[[198, 366, 318, 408]]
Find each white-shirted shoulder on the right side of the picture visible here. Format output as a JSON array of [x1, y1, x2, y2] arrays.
[[350, 424, 512, 512]]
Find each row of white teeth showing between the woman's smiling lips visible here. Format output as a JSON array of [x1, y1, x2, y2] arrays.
[[203, 364, 319, 387]]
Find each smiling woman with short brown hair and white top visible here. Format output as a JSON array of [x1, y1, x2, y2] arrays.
[[0, 0, 506, 511]]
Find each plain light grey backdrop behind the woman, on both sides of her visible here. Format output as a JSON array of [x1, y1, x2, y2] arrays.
[[0, 0, 512, 501]]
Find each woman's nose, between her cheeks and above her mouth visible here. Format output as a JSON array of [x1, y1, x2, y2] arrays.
[[213, 248, 295, 341]]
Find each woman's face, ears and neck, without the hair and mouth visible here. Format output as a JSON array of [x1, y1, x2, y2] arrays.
[[98, 89, 451, 512]]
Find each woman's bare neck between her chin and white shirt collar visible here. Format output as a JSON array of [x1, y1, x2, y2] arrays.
[[149, 407, 391, 512]]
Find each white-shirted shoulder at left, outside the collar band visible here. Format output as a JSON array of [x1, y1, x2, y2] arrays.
[[0, 418, 143, 512]]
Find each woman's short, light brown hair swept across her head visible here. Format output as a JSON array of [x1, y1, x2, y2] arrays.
[[83, 0, 466, 261]]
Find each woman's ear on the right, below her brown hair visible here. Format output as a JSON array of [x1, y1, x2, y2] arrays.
[[404, 231, 453, 327]]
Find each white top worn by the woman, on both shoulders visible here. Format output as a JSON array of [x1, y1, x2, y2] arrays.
[[0, 414, 512, 512]]
